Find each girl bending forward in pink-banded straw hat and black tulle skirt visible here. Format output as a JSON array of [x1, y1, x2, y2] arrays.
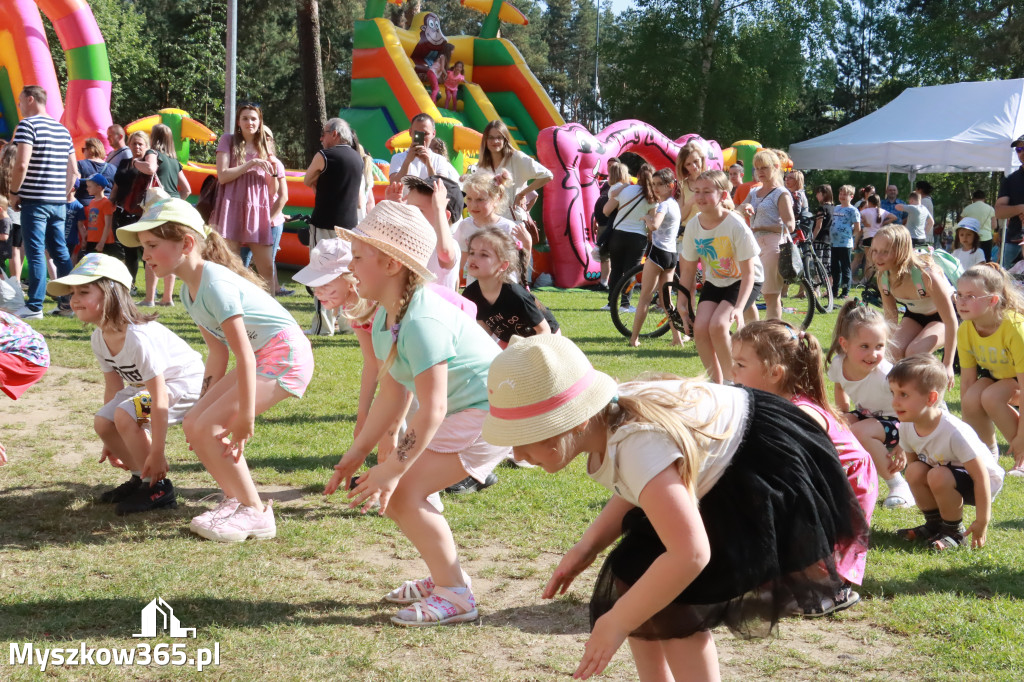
[[483, 335, 867, 680]]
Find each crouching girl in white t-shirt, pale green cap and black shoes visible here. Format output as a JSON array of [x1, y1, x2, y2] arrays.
[[46, 253, 203, 515]]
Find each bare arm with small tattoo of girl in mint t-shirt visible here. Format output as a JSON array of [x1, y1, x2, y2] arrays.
[[348, 361, 447, 514]]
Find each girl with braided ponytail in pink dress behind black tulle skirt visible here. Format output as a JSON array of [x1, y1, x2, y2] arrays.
[[732, 319, 879, 616]]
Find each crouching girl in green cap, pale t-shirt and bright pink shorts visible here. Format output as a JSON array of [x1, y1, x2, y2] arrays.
[[118, 195, 313, 543]]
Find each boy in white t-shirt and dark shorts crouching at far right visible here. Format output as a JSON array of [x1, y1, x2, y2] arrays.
[[889, 353, 1004, 551]]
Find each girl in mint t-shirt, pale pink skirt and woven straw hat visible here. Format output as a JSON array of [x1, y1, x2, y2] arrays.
[[324, 201, 509, 626]]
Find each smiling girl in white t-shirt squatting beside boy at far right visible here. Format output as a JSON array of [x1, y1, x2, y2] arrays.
[[825, 298, 914, 509]]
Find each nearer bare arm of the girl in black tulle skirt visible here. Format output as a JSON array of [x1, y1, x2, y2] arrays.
[[573, 466, 711, 679]]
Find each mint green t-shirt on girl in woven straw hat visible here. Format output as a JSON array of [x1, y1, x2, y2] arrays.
[[372, 287, 501, 415]]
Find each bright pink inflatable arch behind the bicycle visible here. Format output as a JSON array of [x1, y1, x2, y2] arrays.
[[537, 120, 722, 289]]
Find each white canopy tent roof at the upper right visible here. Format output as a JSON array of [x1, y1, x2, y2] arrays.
[[790, 79, 1024, 175]]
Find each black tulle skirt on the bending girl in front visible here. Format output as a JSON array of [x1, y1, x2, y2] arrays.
[[590, 389, 868, 640]]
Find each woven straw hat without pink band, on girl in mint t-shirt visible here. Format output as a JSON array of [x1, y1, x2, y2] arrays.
[[336, 201, 437, 282]]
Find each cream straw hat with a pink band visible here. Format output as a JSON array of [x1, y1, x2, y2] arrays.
[[483, 334, 617, 445]]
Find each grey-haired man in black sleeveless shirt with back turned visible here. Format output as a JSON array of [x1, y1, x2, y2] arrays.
[[302, 119, 362, 336]]
